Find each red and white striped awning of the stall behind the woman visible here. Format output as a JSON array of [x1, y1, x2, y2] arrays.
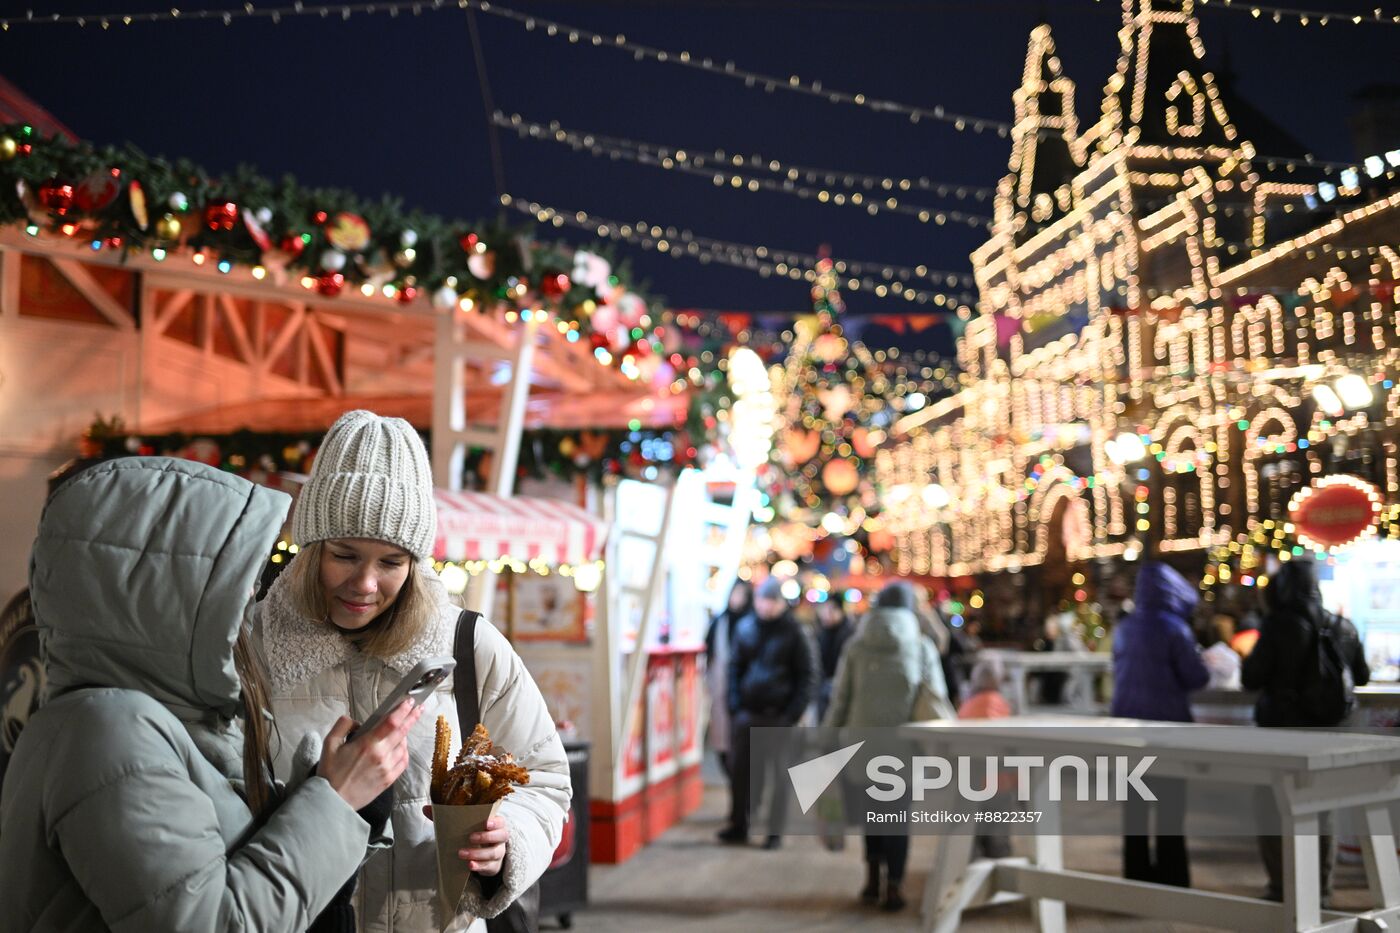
[[433, 489, 608, 565]]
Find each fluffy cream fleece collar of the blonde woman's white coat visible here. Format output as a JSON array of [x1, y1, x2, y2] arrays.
[[258, 555, 461, 693]]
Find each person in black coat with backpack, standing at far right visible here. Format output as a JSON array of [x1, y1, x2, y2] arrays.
[[1240, 558, 1371, 901]]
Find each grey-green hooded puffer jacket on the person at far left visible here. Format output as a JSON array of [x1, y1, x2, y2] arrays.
[[0, 458, 370, 933]]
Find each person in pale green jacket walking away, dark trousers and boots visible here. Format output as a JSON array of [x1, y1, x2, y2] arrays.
[[822, 580, 948, 911]]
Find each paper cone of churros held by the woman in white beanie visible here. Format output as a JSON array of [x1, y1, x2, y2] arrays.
[[431, 716, 529, 929]]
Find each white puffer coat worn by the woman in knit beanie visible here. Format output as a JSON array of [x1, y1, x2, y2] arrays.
[[256, 556, 573, 933]]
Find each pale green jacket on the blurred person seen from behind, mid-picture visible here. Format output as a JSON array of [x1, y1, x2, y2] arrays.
[[822, 608, 948, 728]]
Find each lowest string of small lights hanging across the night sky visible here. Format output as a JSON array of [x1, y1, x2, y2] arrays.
[[501, 193, 973, 308]]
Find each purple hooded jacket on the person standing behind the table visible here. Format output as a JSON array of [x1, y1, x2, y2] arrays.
[[1113, 560, 1211, 723]]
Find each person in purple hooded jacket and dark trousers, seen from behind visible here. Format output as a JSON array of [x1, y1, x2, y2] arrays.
[[1113, 560, 1211, 888]]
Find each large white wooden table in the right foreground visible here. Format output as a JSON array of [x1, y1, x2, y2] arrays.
[[903, 716, 1400, 933]]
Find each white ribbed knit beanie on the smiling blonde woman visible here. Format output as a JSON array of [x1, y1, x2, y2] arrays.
[[291, 410, 437, 560]]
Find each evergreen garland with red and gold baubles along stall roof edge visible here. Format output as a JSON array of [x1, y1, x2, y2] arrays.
[[0, 123, 678, 369]]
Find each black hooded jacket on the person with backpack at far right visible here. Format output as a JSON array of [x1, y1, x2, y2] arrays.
[[1240, 559, 1371, 726]]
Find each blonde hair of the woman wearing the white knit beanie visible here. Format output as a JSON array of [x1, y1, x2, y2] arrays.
[[287, 541, 437, 660]]
